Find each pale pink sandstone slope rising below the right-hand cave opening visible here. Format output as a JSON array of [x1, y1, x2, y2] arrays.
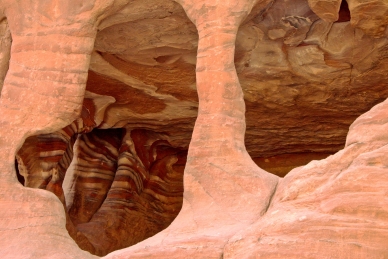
[[224, 97, 388, 258]]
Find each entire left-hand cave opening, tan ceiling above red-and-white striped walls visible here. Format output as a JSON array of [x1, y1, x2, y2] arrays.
[[16, 0, 198, 256]]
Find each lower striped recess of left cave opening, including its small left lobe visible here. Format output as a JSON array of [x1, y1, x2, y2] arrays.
[[17, 124, 187, 255]]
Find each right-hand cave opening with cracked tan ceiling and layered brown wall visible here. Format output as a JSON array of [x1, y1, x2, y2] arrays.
[[235, 0, 388, 177]]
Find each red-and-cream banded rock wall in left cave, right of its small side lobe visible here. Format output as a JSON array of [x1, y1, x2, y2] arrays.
[[69, 129, 186, 255]]
